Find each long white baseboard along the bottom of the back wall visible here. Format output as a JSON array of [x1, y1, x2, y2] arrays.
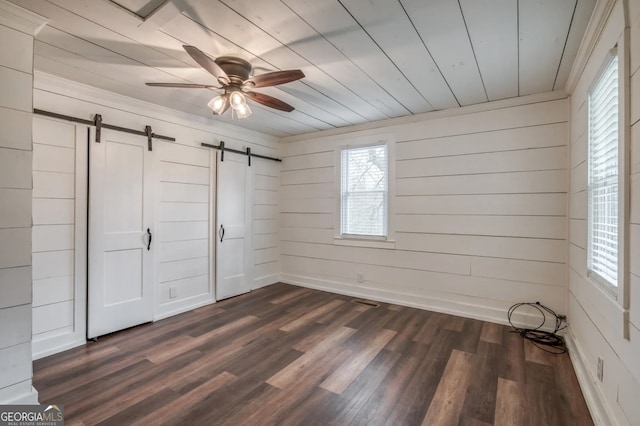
[[280, 274, 553, 331]]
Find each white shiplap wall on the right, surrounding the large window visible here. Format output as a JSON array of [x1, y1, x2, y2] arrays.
[[569, 0, 640, 425]]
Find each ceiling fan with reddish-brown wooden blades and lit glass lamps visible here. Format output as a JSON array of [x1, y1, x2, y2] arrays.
[[146, 45, 304, 118]]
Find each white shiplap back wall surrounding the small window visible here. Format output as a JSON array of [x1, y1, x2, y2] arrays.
[[280, 94, 568, 322]]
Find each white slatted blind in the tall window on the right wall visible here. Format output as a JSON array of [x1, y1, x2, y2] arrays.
[[587, 55, 618, 286]]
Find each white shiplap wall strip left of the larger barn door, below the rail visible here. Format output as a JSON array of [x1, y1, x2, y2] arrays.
[[32, 116, 87, 357]]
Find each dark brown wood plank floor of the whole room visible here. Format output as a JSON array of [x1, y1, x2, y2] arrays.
[[34, 284, 592, 426]]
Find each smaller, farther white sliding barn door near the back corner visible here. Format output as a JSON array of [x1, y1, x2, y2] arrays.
[[215, 153, 253, 300]]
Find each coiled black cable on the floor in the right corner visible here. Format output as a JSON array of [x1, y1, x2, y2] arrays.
[[507, 302, 567, 355]]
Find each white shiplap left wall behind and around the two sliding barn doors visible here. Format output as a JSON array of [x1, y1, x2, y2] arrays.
[[33, 73, 280, 357]]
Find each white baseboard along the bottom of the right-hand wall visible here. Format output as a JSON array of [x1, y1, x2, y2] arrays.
[[564, 326, 615, 425]]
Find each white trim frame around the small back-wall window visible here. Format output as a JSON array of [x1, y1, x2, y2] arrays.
[[333, 133, 395, 249]]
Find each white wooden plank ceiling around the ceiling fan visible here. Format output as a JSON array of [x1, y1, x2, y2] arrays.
[[11, 0, 595, 136]]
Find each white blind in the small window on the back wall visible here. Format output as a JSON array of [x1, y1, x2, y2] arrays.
[[340, 145, 388, 237]]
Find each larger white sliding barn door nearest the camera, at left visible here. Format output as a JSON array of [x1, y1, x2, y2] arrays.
[[87, 129, 156, 338]]
